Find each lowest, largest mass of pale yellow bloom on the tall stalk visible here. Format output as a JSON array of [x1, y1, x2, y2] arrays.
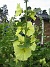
[[13, 41, 36, 61]]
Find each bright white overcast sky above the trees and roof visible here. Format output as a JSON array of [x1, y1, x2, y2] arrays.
[[0, 0, 50, 18]]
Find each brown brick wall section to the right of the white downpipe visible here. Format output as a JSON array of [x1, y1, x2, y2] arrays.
[[44, 22, 50, 41]]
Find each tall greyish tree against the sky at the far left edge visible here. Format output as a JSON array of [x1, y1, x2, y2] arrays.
[[0, 5, 8, 22]]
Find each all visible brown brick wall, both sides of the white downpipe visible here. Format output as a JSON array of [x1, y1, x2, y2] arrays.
[[35, 18, 50, 41]]
